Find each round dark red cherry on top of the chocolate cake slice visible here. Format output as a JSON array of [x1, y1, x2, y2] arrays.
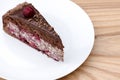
[[23, 6, 35, 18]]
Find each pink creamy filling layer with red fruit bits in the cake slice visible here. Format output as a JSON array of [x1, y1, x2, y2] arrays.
[[6, 22, 63, 61]]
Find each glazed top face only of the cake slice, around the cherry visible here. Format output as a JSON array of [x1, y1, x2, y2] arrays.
[[12, 3, 58, 37]]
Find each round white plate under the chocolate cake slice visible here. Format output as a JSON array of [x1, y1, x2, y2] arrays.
[[0, 0, 94, 80]]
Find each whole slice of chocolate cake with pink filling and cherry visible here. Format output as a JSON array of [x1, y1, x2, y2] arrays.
[[3, 2, 64, 61]]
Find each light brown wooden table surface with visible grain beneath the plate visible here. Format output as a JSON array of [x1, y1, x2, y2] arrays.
[[0, 0, 120, 80]]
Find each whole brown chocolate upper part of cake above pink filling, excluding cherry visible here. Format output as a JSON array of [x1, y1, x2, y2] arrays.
[[3, 2, 64, 50]]
